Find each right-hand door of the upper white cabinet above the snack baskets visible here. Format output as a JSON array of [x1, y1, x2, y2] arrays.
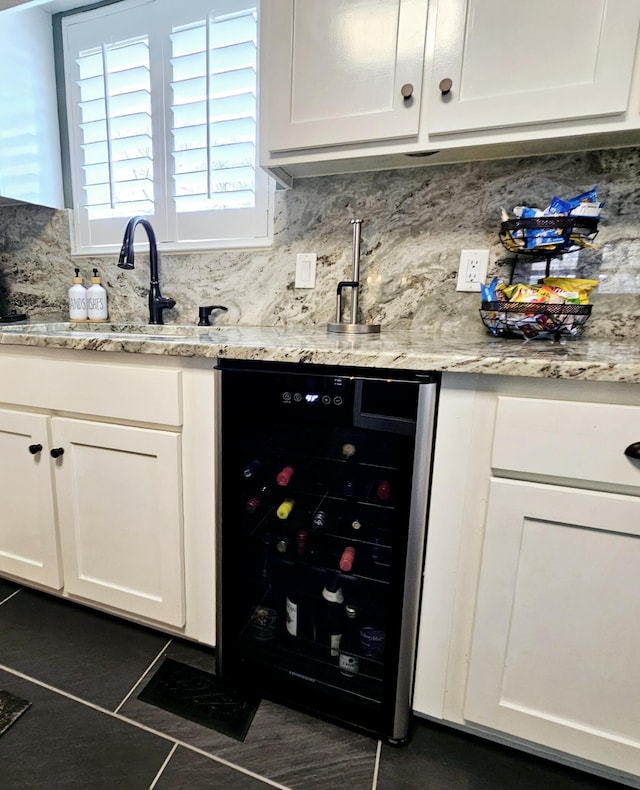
[[427, 0, 640, 134]]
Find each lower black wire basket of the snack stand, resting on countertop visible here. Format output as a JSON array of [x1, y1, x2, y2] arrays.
[[480, 302, 592, 340]]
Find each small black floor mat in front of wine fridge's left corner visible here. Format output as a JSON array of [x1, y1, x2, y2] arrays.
[[138, 658, 260, 741]]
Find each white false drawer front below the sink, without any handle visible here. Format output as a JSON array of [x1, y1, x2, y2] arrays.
[[0, 356, 182, 426]]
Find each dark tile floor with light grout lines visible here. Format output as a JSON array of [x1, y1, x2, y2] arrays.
[[0, 579, 632, 790]]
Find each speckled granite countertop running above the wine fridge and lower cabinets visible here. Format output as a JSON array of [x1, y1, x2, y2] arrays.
[[0, 322, 640, 383]]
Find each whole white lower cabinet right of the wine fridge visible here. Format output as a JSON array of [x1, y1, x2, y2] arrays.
[[413, 374, 640, 788]]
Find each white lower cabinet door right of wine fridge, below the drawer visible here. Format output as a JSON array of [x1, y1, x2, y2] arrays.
[[465, 479, 640, 773]]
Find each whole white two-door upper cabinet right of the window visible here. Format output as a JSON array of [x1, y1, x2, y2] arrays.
[[259, 0, 640, 185]]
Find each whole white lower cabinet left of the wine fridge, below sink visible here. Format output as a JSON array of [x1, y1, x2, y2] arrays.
[[0, 348, 215, 645]]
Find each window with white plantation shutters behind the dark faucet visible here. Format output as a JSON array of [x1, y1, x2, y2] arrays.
[[62, 0, 273, 254]]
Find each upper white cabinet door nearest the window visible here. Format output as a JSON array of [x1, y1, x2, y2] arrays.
[[260, 0, 427, 152]]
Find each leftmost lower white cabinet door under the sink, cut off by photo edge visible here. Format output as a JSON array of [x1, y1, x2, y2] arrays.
[[0, 409, 62, 590]]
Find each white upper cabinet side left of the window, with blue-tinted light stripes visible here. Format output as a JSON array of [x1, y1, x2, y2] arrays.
[[0, 8, 64, 208]]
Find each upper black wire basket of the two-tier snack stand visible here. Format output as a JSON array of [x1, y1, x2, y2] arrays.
[[500, 216, 598, 256]]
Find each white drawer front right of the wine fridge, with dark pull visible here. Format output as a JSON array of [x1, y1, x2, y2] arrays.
[[491, 397, 640, 493]]
